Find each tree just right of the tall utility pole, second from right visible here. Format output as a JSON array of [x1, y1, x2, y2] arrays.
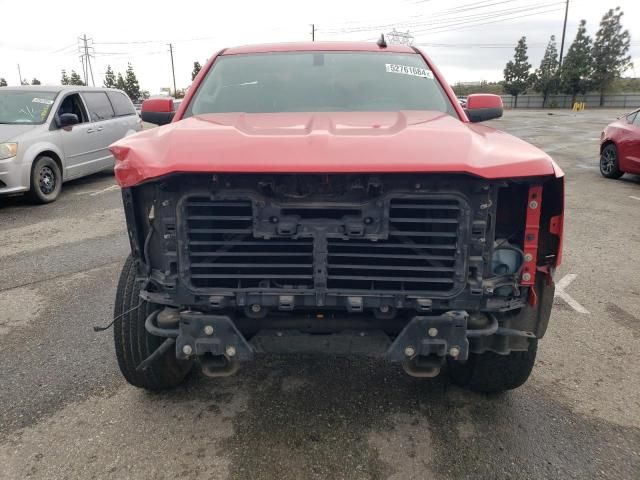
[[560, 20, 592, 105]]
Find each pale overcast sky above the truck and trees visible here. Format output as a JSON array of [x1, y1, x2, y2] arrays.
[[0, 0, 640, 95]]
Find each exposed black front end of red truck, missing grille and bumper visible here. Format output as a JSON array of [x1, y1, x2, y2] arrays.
[[123, 174, 563, 376]]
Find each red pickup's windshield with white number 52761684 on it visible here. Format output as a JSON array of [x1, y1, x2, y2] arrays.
[[184, 52, 457, 118]]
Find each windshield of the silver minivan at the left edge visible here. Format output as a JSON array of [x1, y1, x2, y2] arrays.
[[0, 89, 57, 125]]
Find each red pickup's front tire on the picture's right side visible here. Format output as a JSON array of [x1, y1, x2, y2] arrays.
[[449, 339, 538, 393]]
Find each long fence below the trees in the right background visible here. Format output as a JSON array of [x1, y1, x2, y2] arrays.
[[501, 92, 640, 110]]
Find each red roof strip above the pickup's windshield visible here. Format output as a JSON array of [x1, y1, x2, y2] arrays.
[[222, 42, 416, 55]]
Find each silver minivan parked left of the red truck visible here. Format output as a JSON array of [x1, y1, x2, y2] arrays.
[[0, 86, 142, 203]]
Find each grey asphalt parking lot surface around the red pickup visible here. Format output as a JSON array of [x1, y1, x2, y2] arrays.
[[0, 110, 640, 480]]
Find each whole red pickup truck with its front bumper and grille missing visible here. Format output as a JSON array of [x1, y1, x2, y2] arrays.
[[111, 41, 564, 391]]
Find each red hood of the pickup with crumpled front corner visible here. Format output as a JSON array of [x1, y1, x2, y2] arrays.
[[111, 111, 560, 187]]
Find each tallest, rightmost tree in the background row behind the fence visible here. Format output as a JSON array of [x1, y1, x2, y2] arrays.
[[591, 7, 631, 106]]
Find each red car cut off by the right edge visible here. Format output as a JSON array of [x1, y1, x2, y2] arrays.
[[600, 110, 640, 178]]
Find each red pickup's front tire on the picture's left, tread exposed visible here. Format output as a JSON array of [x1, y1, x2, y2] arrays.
[[113, 256, 193, 390]]
